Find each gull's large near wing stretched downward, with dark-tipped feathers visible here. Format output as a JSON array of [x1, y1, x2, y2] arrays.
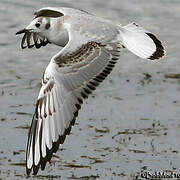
[[26, 7, 121, 175]]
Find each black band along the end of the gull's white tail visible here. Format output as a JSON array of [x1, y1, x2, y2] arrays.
[[146, 33, 165, 60]]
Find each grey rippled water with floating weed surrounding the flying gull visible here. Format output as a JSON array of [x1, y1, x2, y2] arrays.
[[0, 0, 180, 180]]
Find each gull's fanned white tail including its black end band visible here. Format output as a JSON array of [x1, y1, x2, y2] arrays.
[[120, 23, 165, 60]]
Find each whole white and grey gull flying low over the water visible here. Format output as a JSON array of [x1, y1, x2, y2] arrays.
[[16, 7, 165, 175]]
